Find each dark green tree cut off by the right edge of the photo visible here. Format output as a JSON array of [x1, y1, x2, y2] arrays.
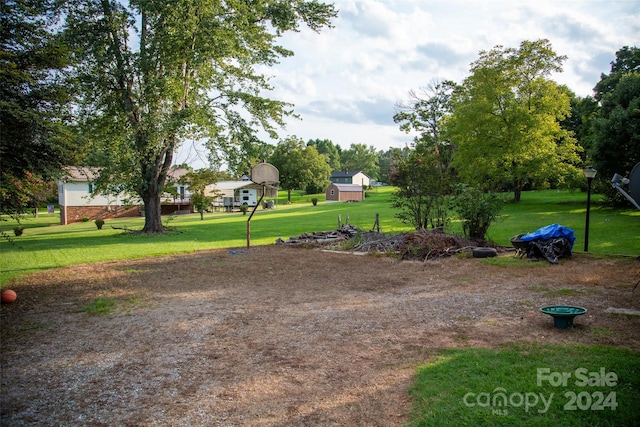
[[589, 47, 640, 188]]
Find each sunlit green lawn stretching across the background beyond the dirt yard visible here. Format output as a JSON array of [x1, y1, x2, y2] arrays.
[[0, 187, 640, 285]]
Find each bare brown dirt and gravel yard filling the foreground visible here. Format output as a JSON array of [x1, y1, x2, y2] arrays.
[[0, 246, 640, 426]]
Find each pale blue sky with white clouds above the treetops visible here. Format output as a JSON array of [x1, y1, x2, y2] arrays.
[[176, 0, 640, 168]]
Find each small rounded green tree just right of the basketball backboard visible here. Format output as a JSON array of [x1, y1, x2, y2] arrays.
[[270, 136, 331, 203]]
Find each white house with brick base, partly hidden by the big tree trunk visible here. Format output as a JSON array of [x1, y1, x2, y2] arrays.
[[58, 166, 193, 224]]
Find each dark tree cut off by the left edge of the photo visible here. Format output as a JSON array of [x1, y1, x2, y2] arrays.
[[0, 0, 80, 215]]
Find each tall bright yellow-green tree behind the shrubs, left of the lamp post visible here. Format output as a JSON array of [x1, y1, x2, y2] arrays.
[[446, 40, 580, 201]]
